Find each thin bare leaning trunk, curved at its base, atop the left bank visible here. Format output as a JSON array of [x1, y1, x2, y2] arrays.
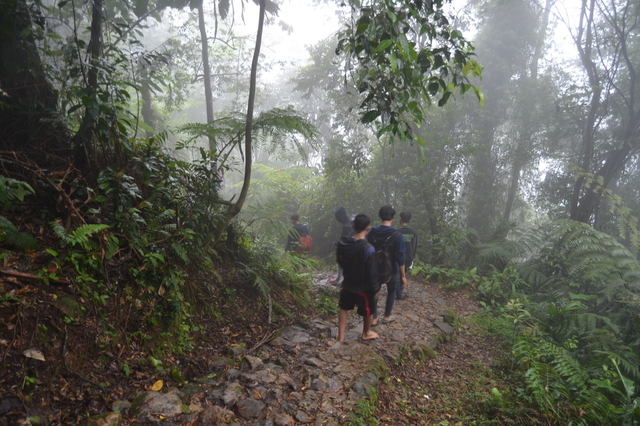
[[213, 0, 266, 244]]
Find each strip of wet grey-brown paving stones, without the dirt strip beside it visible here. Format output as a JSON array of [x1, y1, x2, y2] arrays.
[[84, 279, 470, 426]]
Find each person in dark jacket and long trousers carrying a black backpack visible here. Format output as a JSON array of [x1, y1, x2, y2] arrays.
[[367, 205, 407, 325]]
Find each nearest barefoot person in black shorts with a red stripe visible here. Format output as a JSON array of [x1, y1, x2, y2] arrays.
[[336, 214, 380, 342]]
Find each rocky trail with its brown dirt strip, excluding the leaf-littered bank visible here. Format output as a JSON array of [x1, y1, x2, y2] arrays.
[[0, 276, 504, 426]]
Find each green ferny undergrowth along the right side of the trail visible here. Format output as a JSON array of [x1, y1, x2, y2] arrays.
[[414, 221, 640, 425]]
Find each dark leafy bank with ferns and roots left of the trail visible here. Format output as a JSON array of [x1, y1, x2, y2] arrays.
[[0, 140, 315, 421]]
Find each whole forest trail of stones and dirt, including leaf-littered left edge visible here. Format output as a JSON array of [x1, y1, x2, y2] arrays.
[[0, 276, 508, 426]]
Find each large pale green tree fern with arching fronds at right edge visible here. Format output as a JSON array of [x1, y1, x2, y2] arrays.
[[519, 220, 640, 342]]
